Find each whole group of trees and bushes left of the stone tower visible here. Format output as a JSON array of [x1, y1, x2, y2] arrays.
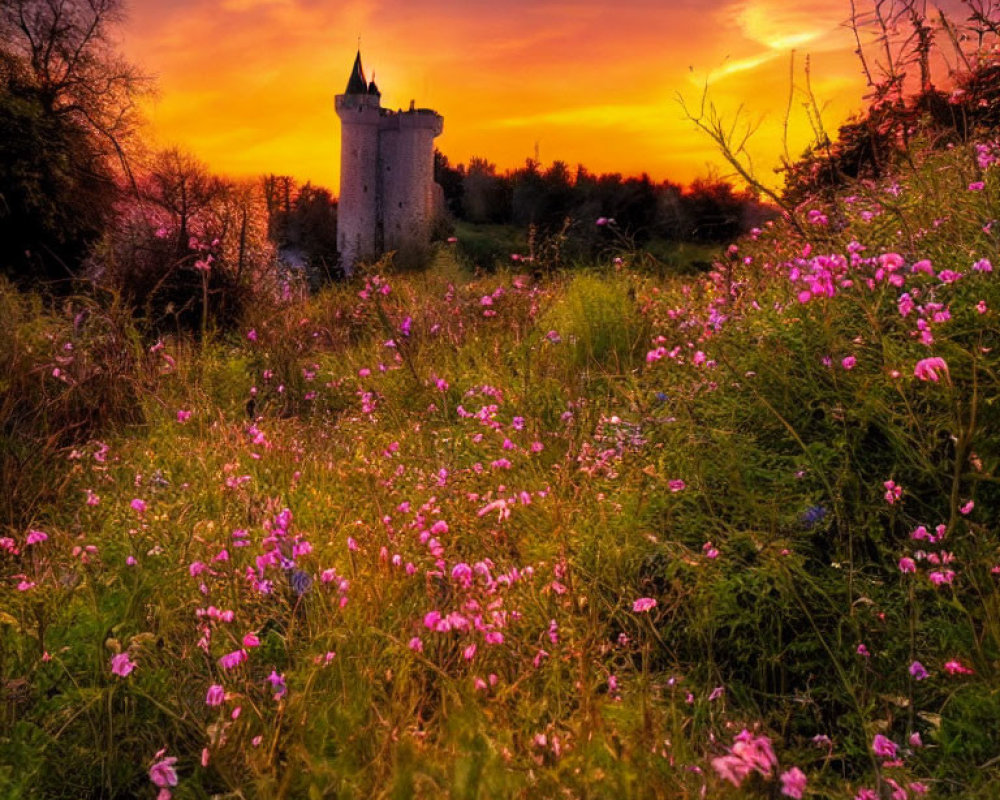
[[0, 0, 352, 336]]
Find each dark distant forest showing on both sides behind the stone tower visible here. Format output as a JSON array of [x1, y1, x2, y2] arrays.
[[263, 151, 776, 277]]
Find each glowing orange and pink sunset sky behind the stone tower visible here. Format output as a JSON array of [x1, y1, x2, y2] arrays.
[[122, 0, 892, 193]]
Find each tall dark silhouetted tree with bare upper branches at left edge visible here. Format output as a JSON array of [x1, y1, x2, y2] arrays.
[[0, 0, 145, 279]]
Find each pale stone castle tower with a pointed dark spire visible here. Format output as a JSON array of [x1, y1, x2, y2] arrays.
[[336, 51, 444, 274]]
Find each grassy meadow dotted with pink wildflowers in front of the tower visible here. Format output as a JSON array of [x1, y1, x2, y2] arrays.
[[0, 141, 1000, 800]]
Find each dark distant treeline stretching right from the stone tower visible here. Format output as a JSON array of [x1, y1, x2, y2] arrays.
[[434, 152, 773, 245]]
